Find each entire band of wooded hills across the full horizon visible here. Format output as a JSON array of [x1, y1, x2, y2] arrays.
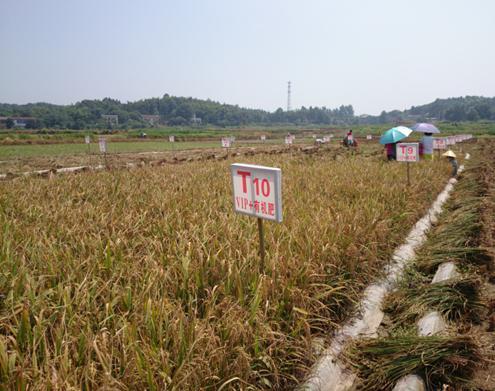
[[0, 94, 495, 129]]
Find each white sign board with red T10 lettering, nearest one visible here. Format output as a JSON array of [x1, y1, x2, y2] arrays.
[[230, 163, 282, 223]]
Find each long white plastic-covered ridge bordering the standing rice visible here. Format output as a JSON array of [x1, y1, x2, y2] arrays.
[[301, 154, 470, 391]]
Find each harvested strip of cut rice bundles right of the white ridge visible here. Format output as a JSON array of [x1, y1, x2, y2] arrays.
[[343, 141, 495, 391]]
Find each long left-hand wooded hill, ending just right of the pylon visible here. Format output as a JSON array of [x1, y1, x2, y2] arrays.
[[0, 94, 354, 129]]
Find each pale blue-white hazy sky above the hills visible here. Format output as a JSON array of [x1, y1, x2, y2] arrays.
[[0, 0, 495, 114]]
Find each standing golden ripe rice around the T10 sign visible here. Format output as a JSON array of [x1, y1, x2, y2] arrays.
[[0, 154, 449, 390]]
